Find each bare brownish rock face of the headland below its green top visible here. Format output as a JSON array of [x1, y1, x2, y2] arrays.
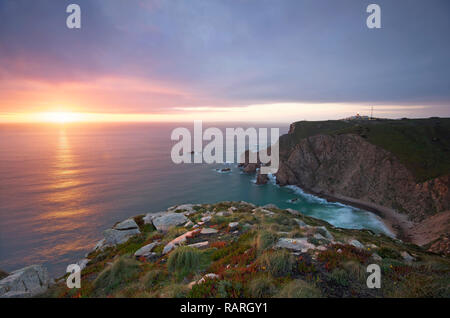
[[276, 134, 450, 220]]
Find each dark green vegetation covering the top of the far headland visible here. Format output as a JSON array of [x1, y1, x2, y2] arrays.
[[280, 118, 450, 182]]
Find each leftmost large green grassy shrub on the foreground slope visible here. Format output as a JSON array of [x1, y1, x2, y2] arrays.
[[93, 256, 140, 295]]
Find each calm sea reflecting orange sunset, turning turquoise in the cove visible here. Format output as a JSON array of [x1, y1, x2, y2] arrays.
[[0, 123, 389, 276]]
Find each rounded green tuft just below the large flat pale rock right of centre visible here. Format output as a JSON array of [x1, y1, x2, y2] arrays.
[[259, 250, 296, 277]]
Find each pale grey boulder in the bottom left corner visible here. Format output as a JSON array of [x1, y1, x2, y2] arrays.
[[0, 265, 50, 298]]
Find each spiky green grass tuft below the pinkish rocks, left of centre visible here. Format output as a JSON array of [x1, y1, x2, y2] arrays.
[[167, 246, 201, 275]]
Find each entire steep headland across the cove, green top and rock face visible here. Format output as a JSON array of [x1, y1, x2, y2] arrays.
[[248, 119, 450, 252]]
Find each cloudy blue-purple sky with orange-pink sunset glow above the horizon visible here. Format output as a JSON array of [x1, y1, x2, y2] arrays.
[[0, 0, 450, 122]]
